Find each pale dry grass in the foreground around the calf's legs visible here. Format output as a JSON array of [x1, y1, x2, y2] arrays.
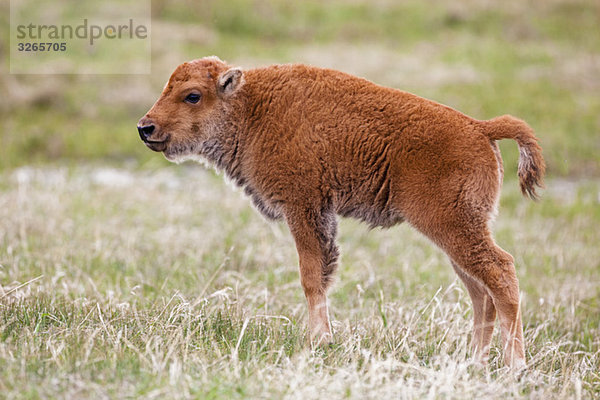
[[0, 166, 600, 399]]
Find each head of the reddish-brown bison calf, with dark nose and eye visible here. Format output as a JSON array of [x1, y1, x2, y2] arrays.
[[137, 57, 244, 161]]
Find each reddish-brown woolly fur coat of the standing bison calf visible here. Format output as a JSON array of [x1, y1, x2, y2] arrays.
[[139, 57, 545, 366]]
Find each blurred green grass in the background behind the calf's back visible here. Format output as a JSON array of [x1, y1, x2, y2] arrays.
[[0, 0, 600, 175]]
